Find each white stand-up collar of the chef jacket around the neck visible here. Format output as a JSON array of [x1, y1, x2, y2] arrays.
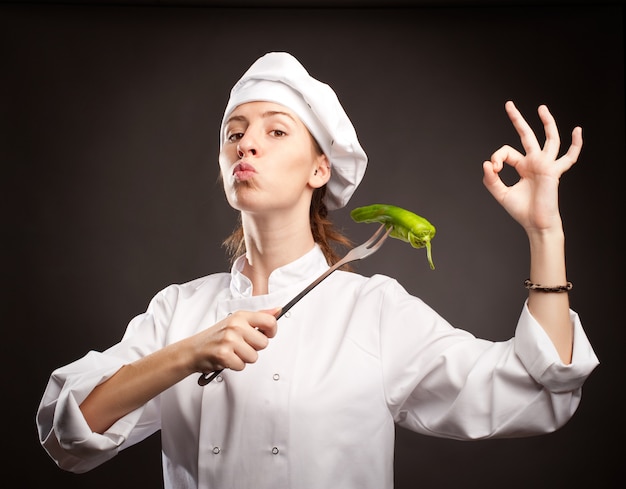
[[230, 243, 328, 298]]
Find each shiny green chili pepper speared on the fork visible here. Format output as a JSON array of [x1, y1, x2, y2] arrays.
[[350, 204, 435, 270]]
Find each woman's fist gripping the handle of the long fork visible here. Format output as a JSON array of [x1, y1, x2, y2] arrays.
[[189, 308, 280, 373]]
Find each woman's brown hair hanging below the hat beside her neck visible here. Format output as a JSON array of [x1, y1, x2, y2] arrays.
[[222, 185, 352, 270]]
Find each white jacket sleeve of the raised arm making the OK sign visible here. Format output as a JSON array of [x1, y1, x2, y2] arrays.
[[370, 281, 598, 440]]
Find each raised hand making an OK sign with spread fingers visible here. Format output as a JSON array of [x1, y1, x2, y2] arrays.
[[483, 101, 583, 233]]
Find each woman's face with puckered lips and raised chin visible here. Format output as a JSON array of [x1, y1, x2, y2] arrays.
[[219, 102, 330, 212]]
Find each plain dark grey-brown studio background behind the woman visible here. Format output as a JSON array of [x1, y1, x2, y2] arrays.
[[0, 1, 625, 489]]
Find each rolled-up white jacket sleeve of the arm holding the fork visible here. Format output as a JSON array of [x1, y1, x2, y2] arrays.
[[36, 289, 172, 473]]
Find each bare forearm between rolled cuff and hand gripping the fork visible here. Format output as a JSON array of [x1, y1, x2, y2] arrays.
[[80, 343, 193, 433]]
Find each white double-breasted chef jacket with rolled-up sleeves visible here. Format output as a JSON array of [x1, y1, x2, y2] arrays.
[[37, 245, 598, 489]]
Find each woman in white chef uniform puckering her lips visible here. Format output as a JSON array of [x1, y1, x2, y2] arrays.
[[37, 53, 598, 489]]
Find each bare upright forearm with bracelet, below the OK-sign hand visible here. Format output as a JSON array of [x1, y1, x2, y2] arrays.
[[528, 228, 573, 364]]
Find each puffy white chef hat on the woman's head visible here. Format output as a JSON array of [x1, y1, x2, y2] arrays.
[[220, 53, 367, 209]]
